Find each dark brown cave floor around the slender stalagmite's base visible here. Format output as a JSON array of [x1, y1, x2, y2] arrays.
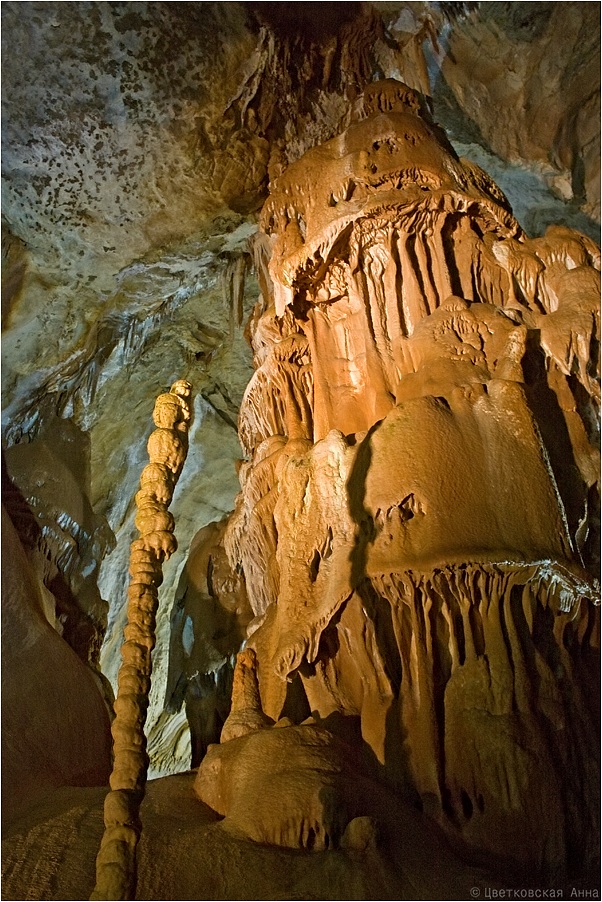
[[2, 772, 594, 902]]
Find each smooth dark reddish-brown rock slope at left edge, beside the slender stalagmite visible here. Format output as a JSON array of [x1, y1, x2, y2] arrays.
[[2, 507, 111, 824]]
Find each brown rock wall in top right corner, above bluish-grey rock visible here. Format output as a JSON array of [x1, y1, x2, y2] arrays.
[[441, 3, 600, 221]]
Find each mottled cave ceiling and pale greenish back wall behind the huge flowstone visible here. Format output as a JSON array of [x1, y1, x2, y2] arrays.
[[2, 2, 600, 776]]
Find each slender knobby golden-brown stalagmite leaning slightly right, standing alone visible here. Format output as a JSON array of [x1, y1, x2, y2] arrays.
[[90, 380, 191, 899]]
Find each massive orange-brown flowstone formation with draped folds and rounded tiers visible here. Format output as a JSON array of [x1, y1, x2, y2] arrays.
[[196, 81, 600, 879]]
